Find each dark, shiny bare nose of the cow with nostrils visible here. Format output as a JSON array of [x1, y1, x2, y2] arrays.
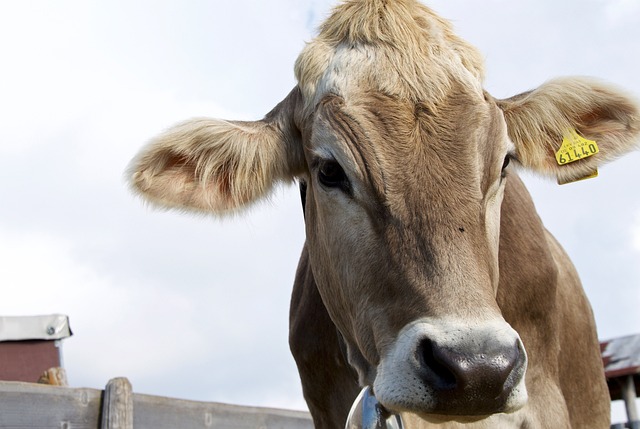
[[416, 338, 526, 413]]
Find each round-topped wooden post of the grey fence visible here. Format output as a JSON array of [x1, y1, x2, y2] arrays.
[[100, 377, 133, 429]]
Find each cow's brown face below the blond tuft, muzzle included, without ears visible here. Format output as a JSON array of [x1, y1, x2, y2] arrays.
[[300, 49, 527, 415]]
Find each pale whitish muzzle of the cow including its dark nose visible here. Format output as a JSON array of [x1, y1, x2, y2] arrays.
[[374, 319, 527, 417]]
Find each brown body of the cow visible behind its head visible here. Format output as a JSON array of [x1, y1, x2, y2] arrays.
[[290, 171, 609, 429]]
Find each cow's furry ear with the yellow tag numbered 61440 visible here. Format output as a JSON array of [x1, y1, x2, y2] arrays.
[[498, 78, 640, 183]]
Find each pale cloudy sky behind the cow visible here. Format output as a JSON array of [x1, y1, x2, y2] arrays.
[[0, 0, 640, 422]]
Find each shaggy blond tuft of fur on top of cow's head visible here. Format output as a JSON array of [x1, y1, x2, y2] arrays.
[[295, 0, 484, 103]]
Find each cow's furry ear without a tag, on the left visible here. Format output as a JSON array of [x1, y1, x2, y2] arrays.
[[128, 87, 305, 214]]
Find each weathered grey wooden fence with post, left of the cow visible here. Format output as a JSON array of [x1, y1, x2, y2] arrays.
[[0, 378, 313, 429]]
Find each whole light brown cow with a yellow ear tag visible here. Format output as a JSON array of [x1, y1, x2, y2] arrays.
[[129, 0, 640, 428]]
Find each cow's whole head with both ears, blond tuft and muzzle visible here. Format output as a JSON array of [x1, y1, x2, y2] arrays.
[[131, 0, 640, 422]]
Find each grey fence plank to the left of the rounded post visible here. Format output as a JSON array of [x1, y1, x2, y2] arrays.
[[0, 382, 102, 429]]
